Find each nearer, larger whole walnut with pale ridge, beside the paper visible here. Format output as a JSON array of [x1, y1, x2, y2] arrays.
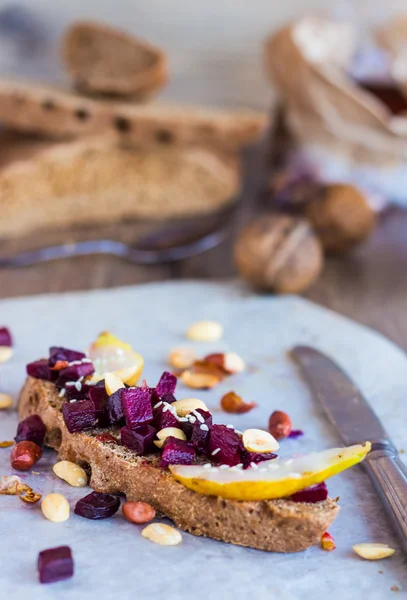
[[235, 214, 323, 294]]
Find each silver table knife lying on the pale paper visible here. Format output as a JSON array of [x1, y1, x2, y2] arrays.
[[291, 346, 407, 554]]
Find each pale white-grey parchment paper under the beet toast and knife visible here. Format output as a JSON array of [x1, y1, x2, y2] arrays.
[[0, 282, 407, 600]]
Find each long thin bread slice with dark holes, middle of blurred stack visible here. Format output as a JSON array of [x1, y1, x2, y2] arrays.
[[0, 80, 268, 151]]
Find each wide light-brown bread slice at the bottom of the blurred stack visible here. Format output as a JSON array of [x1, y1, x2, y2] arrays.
[[0, 135, 239, 238]]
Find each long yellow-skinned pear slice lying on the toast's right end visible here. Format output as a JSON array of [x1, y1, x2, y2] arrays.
[[170, 442, 371, 501]]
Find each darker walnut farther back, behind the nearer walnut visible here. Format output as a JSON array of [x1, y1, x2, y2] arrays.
[[305, 183, 376, 252]]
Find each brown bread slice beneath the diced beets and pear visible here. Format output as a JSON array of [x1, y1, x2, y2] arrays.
[[19, 377, 339, 552]]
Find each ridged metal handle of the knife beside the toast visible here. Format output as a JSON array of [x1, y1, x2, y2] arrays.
[[362, 443, 407, 554]]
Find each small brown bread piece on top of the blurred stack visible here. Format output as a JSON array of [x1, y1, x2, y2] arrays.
[[62, 22, 168, 100]]
